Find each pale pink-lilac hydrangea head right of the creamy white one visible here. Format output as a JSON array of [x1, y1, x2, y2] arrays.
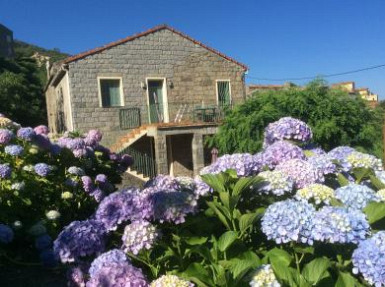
[[276, 159, 325, 188]]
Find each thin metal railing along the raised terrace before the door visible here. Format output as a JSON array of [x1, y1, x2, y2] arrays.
[[148, 103, 230, 123]]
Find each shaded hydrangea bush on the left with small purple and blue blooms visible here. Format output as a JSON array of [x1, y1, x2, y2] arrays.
[[0, 115, 131, 266]]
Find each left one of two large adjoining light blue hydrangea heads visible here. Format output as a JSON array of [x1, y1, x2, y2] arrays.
[[262, 199, 315, 244]]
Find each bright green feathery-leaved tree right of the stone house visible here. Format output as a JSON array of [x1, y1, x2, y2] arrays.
[[208, 80, 383, 158]]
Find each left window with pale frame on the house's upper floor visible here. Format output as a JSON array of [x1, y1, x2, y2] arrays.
[[99, 78, 123, 107]]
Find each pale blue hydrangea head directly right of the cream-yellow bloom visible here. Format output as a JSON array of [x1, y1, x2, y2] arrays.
[[335, 186, 381, 209]]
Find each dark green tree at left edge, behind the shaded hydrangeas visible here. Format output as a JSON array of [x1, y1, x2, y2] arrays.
[[0, 57, 47, 126]]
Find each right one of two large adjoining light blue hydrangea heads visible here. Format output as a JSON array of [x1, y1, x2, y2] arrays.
[[312, 206, 370, 243]]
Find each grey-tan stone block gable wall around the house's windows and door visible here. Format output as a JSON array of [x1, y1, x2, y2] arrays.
[[69, 29, 245, 145]]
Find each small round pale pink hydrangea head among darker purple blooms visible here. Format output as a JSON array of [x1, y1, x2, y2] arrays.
[[122, 220, 159, 255]]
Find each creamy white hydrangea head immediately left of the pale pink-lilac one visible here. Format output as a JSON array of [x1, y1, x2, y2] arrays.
[[254, 170, 293, 196]]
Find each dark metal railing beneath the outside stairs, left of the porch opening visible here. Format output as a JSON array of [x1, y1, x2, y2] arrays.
[[119, 147, 156, 178]]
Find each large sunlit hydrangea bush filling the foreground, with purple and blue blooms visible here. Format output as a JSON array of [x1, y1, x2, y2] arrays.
[[6, 118, 385, 287]]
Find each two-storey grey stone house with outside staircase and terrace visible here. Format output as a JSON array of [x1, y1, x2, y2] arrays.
[[46, 25, 247, 181]]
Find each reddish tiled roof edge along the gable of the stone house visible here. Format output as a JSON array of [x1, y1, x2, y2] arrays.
[[63, 25, 248, 71]]
